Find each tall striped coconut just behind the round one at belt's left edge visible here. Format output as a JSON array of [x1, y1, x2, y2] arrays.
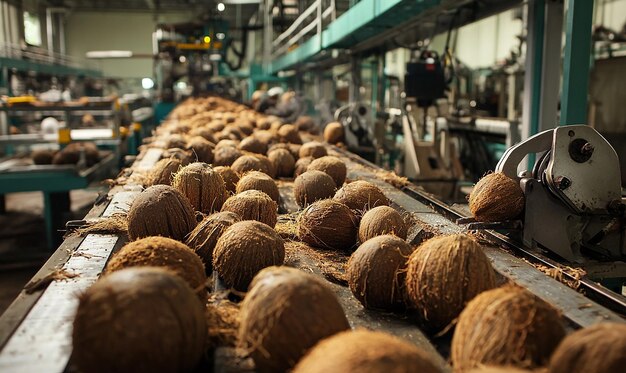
[[172, 162, 227, 214]]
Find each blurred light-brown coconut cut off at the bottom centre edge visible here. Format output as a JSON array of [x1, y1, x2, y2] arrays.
[[293, 329, 442, 373]]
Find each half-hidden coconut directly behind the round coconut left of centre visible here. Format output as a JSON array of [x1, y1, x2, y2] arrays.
[[222, 190, 278, 228]]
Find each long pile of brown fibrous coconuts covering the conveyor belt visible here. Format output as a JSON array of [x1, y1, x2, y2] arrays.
[[66, 97, 584, 373]]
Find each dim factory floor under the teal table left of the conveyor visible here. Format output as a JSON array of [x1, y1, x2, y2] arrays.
[[0, 183, 107, 314]]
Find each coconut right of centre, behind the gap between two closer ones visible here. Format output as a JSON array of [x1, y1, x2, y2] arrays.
[[335, 180, 390, 213]]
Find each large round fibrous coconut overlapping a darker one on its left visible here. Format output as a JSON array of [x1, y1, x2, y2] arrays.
[[406, 234, 496, 331]]
